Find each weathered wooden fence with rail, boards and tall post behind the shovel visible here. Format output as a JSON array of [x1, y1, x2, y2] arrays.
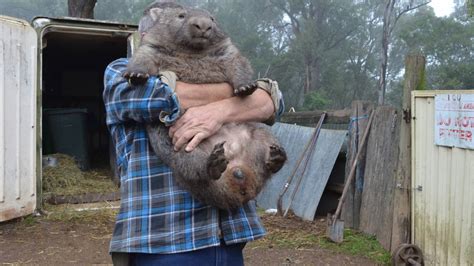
[[282, 56, 424, 252]]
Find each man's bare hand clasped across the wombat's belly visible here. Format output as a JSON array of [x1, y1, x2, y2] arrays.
[[169, 103, 224, 152]]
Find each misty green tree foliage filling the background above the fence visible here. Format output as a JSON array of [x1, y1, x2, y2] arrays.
[[0, 0, 474, 110]]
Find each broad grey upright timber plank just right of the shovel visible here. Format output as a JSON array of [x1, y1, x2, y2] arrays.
[[359, 106, 401, 250]]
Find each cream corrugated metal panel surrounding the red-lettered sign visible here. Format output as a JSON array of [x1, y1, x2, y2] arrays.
[[412, 91, 474, 265]]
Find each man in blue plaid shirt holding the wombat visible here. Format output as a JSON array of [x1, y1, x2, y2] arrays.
[[104, 1, 283, 265]]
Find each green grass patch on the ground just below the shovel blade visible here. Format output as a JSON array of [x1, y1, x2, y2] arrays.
[[319, 229, 391, 265]]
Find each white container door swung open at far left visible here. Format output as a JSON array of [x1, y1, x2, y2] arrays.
[[0, 16, 37, 222]]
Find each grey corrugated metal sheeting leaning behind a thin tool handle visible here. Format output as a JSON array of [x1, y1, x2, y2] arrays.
[[257, 123, 347, 221]]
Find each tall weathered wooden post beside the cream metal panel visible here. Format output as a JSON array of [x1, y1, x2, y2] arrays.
[[391, 55, 425, 254]]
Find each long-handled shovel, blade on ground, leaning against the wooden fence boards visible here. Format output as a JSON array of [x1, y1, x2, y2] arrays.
[[326, 111, 375, 243]]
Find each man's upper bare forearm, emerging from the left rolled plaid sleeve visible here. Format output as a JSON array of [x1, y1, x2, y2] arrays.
[[176, 81, 233, 109]]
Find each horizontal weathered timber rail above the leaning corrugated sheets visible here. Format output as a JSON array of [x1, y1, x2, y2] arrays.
[[280, 109, 351, 126]]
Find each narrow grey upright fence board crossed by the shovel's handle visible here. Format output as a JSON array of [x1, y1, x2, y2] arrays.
[[342, 101, 374, 229]]
